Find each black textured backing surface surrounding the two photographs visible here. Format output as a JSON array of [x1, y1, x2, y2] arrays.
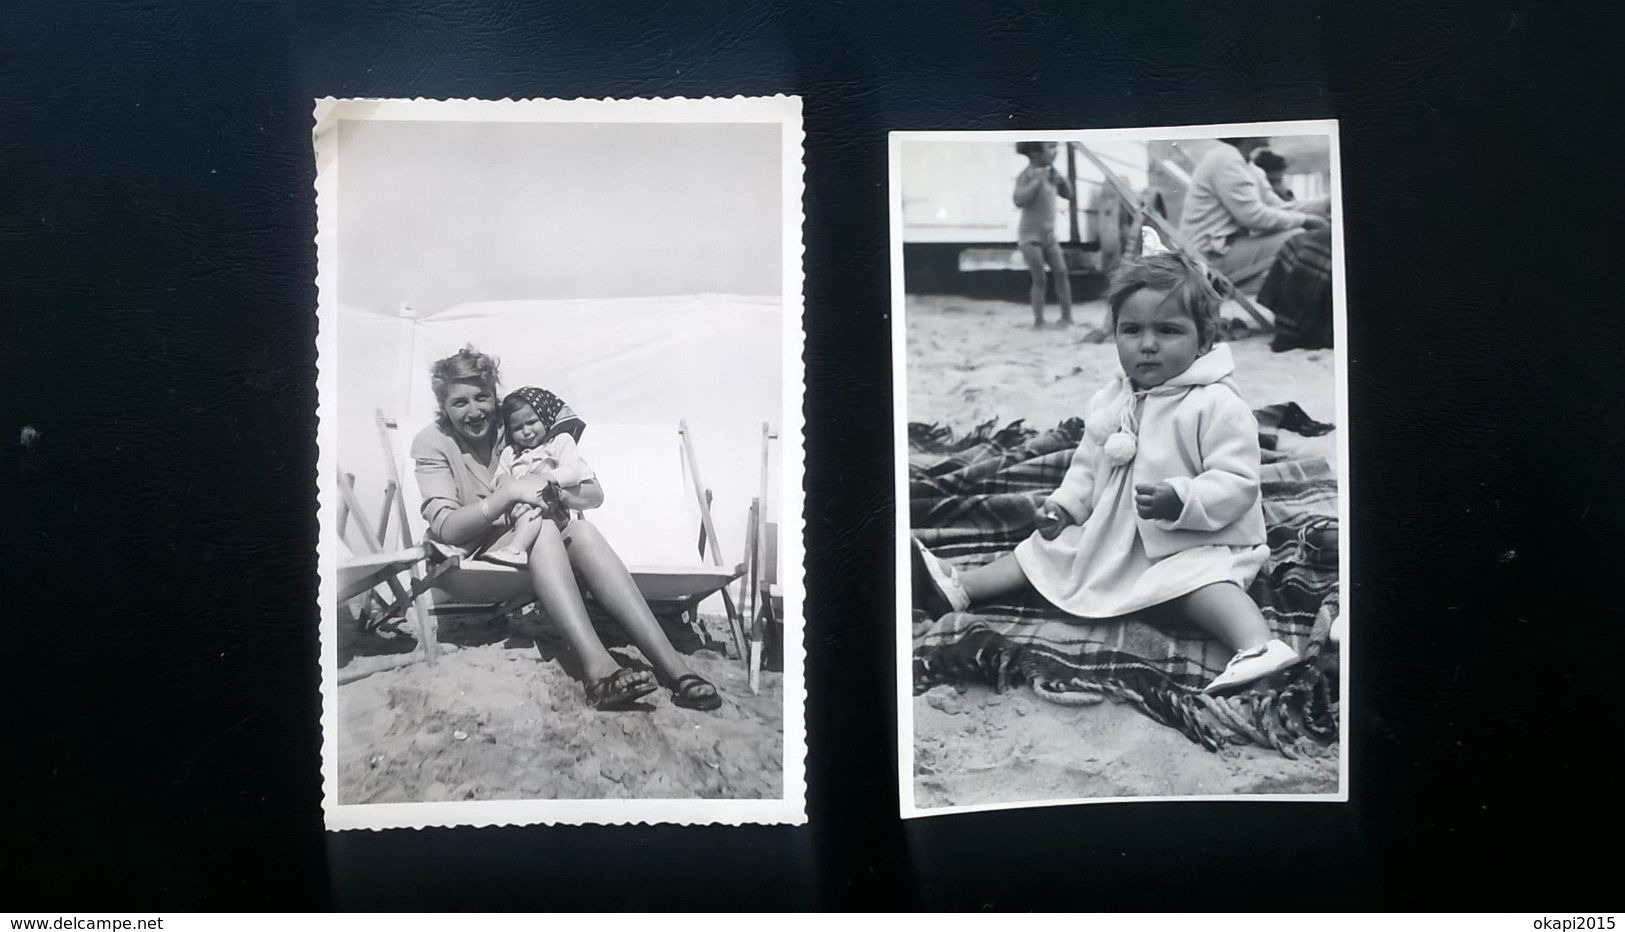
[[0, 0, 1625, 911]]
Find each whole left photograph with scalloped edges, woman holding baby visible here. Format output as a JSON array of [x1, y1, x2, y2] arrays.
[[315, 97, 804, 828]]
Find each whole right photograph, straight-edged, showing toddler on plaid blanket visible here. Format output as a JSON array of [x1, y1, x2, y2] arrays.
[[891, 122, 1349, 815]]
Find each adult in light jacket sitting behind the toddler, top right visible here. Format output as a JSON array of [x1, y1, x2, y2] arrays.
[[1180, 136, 1328, 297]]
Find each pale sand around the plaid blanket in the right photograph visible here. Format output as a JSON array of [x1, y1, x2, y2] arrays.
[[905, 296, 1339, 807]]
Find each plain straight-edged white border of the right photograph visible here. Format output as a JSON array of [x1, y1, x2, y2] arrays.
[[887, 120, 1355, 818]]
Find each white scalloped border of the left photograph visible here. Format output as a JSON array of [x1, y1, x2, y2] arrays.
[[312, 94, 806, 830]]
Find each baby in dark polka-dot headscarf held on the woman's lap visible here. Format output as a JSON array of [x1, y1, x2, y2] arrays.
[[481, 385, 595, 567]]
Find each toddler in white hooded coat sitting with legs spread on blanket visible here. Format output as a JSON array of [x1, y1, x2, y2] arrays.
[[913, 231, 1298, 692]]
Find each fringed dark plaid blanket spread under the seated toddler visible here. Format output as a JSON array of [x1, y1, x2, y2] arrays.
[[908, 404, 1337, 757]]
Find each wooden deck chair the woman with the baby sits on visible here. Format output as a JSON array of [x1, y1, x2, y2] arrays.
[[365, 411, 744, 668]]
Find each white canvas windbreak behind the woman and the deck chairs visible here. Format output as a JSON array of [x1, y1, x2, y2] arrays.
[[338, 296, 780, 578]]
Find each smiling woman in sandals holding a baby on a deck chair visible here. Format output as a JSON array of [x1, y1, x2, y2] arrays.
[[411, 346, 722, 710]]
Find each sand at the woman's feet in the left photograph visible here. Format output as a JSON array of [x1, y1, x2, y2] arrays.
[[336, 617, 783, 804]]
